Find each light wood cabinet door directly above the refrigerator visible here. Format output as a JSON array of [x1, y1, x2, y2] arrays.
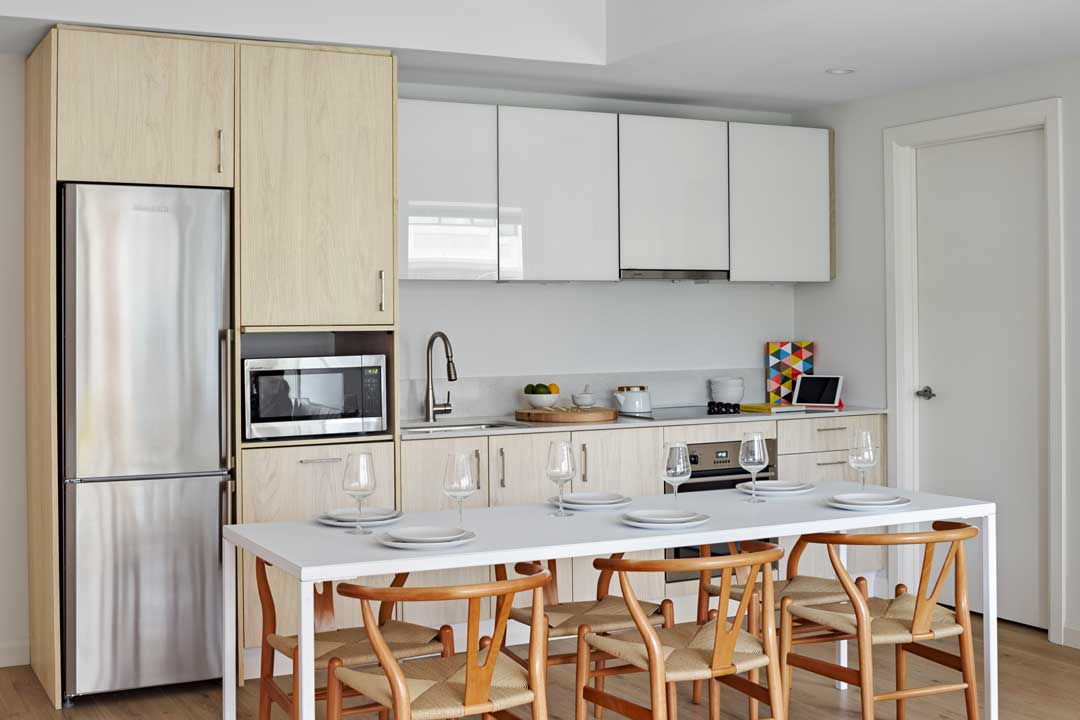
[[56, 29, 237, 187]]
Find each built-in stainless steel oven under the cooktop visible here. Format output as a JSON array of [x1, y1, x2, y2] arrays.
[[664, 439, 777, 583]]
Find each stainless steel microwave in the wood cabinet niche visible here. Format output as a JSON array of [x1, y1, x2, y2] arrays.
[[244, 355, 387, 440]]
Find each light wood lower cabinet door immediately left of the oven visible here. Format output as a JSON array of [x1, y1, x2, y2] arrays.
[[571, 427, 664, 601]]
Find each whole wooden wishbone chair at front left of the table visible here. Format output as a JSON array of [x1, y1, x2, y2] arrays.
[[326, 571, 550, 720]]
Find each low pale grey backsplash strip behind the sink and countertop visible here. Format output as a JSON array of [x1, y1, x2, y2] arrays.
[[397, 369, 765, 420]]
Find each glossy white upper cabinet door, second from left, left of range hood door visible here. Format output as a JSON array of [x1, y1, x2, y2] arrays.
[[499, 107, 619, 281]]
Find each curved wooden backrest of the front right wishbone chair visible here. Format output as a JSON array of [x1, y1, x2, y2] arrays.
[[799, 521, 978, 640]]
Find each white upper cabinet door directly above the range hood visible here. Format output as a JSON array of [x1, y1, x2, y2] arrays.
[[619, 116, 728, 276]]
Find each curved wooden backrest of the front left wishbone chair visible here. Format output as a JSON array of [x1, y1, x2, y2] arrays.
[[338, 570, 551, 716]]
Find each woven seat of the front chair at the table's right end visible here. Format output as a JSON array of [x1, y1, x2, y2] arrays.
[[791, 593, 963, 644]]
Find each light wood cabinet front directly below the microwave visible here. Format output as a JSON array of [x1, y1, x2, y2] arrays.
[[240, 443, 395, 648]]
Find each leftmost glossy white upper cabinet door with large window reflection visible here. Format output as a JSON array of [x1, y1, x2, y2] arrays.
[[397, 100, 499, 281]]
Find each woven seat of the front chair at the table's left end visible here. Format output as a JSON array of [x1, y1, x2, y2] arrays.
[[335, 653, 534, 720]]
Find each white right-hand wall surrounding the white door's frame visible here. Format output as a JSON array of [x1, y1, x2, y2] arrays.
[[795, 58, 1080, 643]]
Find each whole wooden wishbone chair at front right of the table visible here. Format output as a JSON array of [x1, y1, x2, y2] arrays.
[[780, 522, 978, 720]]
